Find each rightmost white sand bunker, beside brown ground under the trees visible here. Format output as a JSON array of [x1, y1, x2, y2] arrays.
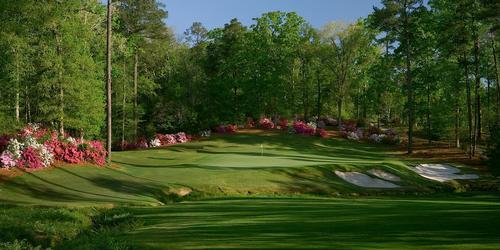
[[411, 164, 479, 182]]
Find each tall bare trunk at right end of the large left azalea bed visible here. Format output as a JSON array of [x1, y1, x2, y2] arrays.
[[106, 0, 113, 165]]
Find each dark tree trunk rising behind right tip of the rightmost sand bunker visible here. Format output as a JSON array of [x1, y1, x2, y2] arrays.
[[472, 37, 481, 156]]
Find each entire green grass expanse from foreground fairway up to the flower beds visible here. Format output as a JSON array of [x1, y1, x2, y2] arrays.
[[0, 134, 500, 249]]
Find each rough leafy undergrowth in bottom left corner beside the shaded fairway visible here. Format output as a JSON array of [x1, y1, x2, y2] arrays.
[[0, 206, 141, 250]]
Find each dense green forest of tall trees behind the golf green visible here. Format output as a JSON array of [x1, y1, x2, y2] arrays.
[[0, 0, 500, 163]]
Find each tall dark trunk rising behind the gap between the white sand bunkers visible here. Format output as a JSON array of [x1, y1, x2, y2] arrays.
[[403, 0, 414, 154]]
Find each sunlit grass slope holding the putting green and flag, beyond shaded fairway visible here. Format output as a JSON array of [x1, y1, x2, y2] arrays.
[[0, 134, 480, 206]]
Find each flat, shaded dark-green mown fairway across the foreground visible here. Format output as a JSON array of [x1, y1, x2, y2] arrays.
[[122, 197, 500, 249]]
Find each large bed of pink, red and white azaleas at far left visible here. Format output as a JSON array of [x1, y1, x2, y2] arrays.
[[0, 124, 107, 169]]
